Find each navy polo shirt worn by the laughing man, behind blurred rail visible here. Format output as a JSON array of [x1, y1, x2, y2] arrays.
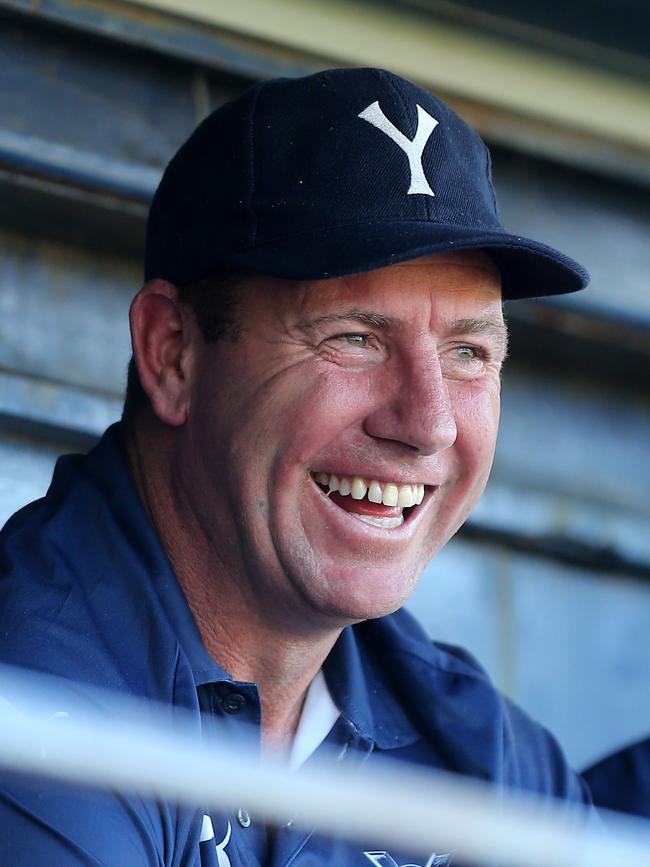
[[0, 425, 590, 867]]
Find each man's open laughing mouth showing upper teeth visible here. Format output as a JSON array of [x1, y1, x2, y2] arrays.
[[311, 472, 425, 530]]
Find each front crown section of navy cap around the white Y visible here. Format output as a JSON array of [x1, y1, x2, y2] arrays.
[[248, 69, 499, 243]]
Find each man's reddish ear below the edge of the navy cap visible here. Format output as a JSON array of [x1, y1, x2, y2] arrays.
[[129, 280, 193, 427]]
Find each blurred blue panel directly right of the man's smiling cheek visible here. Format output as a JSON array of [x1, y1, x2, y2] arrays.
[[488, 367, 650, 566]]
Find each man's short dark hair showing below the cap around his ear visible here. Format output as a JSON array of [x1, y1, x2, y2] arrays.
[[122, 268, 246, 423]]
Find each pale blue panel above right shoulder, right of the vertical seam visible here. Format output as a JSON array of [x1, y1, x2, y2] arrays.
[[510, 557, 650, 767]]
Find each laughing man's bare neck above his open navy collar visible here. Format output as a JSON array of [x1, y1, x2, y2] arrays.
[[126, 421, 340, 752]]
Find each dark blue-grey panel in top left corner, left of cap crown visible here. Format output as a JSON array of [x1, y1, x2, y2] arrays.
[[0, 10, 198, 168]]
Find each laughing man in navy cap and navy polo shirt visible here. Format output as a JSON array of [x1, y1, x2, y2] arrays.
[[0, 69, 588, 867]]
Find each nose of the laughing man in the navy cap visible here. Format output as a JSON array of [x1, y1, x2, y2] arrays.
[[364, 353, 458, 455]]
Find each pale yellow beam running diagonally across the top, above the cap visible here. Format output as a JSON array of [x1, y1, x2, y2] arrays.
[[125, 0, 650, 150]]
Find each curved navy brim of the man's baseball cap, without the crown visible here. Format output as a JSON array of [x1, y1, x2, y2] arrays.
[[223, 220, 589, 299]]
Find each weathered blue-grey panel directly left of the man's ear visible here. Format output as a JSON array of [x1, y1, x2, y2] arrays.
[[0, 229, 135, 395]]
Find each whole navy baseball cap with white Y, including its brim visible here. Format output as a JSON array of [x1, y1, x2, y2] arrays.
[[145, 68, 589, 298]]
